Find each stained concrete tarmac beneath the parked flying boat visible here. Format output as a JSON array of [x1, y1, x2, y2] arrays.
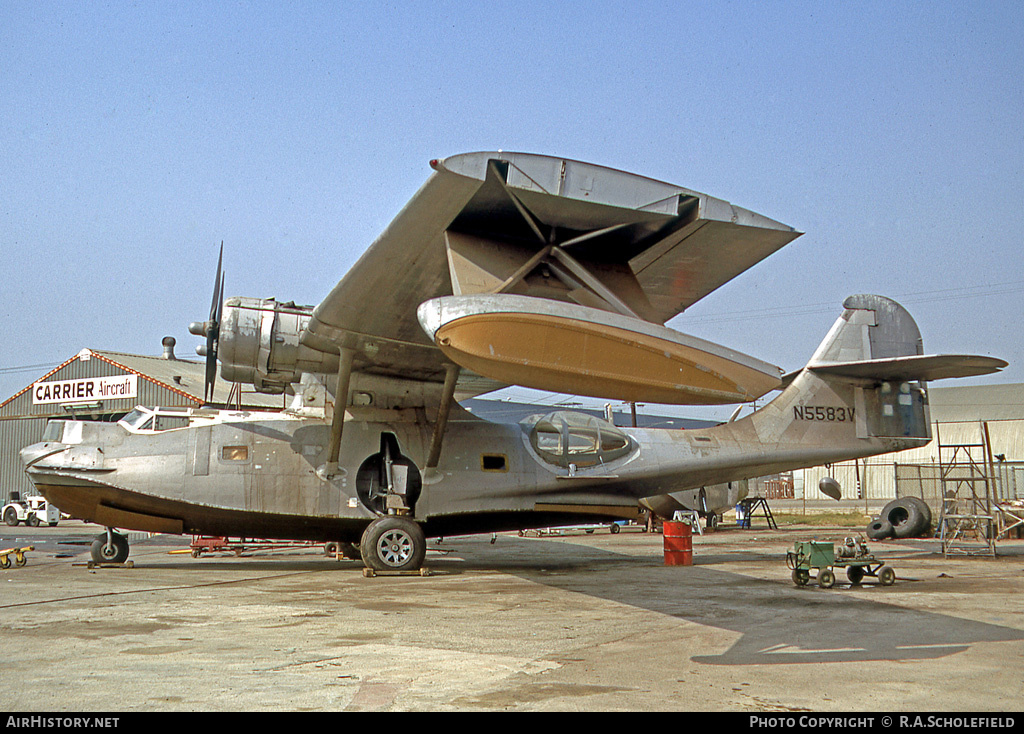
[[0, 521, 1024, 716]]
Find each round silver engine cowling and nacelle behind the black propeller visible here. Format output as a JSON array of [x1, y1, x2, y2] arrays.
[[218, 298, 338, 394]]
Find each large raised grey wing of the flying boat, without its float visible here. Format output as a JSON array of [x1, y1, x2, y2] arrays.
[[301, 153, 800, 389]]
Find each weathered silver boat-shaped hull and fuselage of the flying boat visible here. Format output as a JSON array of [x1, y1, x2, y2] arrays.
[[23, 373, 929, 541]]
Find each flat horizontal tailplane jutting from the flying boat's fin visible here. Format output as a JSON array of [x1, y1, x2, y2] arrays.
[[807, 354, 1008, 382]]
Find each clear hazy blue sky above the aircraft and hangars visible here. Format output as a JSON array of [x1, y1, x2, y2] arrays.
[[0, 0, 1024, 416]]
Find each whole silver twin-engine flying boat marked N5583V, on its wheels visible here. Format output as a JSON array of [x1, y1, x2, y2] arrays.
[[22, 153, 1006, 570]]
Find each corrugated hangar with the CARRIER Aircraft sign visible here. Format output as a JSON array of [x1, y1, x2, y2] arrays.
[[0, 337, 287, 504]]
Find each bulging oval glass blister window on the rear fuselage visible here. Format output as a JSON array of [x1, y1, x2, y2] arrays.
[[529, 411, 630, 468]]
